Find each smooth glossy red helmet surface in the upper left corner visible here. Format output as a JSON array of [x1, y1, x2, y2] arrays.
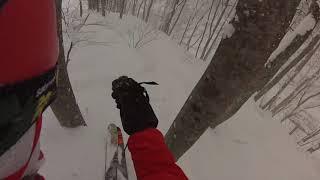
[[0, 0, 58, 84]]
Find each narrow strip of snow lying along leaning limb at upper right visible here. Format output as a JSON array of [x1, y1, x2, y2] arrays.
[[266, 13, 316, 65]]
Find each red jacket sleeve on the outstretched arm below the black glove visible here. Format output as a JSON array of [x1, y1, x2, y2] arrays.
[[128, 129, 188, 180]]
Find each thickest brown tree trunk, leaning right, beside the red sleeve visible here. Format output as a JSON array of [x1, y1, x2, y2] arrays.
[[166, 0, 299, 159]]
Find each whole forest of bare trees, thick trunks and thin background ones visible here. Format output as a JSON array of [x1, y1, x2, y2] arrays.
[[52, 0, 320, 159]]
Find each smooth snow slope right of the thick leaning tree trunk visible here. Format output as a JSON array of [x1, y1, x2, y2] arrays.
[[179, 99, 319, 180]]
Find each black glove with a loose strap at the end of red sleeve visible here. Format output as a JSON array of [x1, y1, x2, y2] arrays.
[[112, 76, 158, 135]]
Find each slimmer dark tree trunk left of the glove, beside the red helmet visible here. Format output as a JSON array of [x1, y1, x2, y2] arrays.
[[51, 0, 86, 127]]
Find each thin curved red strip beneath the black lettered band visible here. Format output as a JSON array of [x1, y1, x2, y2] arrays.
[[5, 117, 44, 180]]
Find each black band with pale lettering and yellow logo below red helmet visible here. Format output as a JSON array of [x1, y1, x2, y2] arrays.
[[0, 67, 57, 156]]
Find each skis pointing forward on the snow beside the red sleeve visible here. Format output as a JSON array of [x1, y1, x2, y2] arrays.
[[105, 124, 128, 180]]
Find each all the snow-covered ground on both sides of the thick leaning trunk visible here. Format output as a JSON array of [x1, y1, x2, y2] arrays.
[[41, 13, 319, 180]]
